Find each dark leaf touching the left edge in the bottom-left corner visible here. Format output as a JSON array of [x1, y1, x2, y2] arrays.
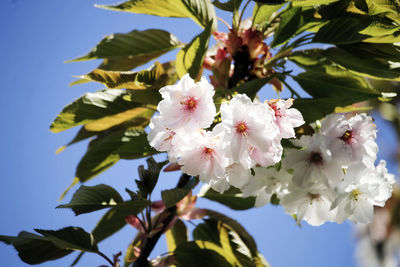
[[0, 231, 72, 264]]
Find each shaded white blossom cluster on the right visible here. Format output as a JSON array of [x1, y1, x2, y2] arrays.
[[244, 114, 395, 225]]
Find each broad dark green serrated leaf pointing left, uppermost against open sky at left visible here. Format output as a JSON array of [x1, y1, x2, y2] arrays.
[[68, 29, 182, 69]]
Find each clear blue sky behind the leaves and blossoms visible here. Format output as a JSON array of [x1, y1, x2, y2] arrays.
[[0, 0, 395, 267]]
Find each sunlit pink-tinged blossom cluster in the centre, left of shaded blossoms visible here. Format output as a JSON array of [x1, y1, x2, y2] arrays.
[[148, 74, 304, 193]]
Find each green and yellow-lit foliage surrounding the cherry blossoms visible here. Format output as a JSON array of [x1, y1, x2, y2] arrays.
[[0, 0, 400, 266]]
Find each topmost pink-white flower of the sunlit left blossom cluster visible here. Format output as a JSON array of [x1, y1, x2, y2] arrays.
[[157, 74, 216, 131]]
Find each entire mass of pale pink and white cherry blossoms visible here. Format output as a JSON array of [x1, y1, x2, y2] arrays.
[[148, 75, 394, 225]]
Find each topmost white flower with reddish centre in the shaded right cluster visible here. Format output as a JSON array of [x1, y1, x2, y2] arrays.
[[321, 113, 378, 166]]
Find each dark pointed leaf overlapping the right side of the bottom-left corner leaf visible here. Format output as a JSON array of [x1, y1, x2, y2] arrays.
[[35, 226, 99, 253]]
